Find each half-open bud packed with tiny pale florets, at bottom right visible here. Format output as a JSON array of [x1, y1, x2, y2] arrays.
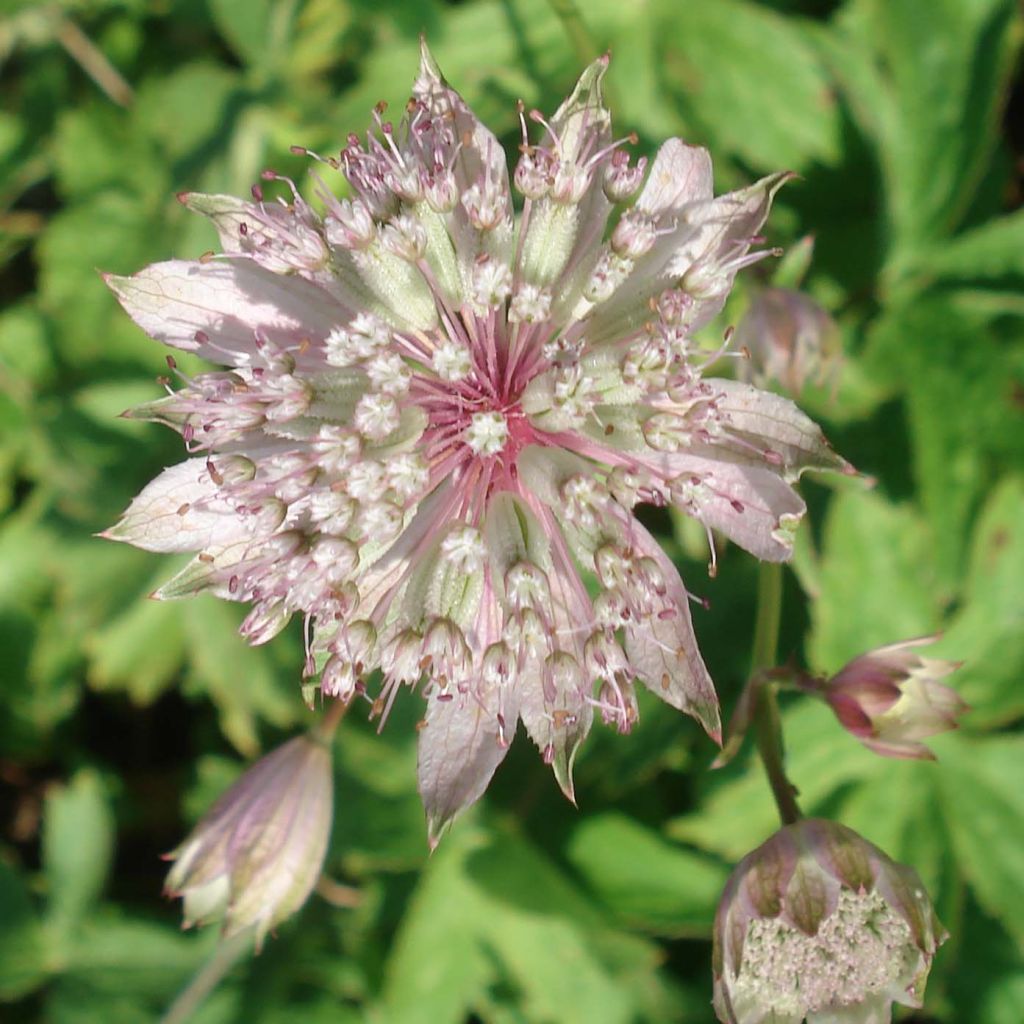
[[713, 819, 946, 1024]]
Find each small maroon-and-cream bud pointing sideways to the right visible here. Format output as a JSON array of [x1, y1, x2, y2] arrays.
[[818, 637, 968, 759]]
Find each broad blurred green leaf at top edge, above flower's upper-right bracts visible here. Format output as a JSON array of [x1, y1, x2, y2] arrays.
[[659, 0, 839, 170]]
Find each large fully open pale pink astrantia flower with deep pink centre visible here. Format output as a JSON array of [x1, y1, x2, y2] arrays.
[[108, 41, 843, 837]]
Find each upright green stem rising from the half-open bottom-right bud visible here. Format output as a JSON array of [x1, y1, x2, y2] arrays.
[[751, 562, 803, 825]]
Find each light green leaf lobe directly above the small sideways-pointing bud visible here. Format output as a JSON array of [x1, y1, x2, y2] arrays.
[[808, 489, 939, 672]]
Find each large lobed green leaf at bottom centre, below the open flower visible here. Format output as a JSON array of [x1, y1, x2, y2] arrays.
[[384, 822, 665, 1024]]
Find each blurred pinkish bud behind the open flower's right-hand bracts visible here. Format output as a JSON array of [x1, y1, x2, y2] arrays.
[[733, 288, 842, 395]]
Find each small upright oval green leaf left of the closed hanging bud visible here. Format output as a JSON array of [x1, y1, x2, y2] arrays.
[[43, 769, 114, 932]]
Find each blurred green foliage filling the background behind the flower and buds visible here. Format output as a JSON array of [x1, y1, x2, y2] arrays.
[[0, 0, 1024, 1024]]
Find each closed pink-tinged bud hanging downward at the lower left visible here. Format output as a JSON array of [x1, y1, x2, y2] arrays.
[[167, 734, 334, 945]]
